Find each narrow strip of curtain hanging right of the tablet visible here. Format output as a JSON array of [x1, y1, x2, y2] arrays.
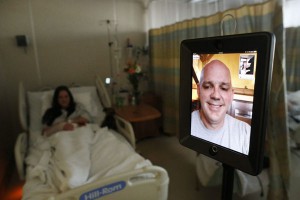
[[267, 2, 290, 199]]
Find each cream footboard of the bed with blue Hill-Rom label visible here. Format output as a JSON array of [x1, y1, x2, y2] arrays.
[[49, 166, 169, 200]]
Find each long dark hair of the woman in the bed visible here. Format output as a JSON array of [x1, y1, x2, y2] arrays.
[[42, 85, 76, 126]]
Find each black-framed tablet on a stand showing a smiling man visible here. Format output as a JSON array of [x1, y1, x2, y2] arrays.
[[179, 32, 275, 175]]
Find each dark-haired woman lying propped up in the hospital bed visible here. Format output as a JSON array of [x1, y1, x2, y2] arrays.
[[42, 86, 91, 137]]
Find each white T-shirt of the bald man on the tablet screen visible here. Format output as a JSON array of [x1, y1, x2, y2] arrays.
[[191, 110, 251, 155]]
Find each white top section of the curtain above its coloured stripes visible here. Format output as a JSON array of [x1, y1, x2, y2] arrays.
[[145, 0, 268, 29]]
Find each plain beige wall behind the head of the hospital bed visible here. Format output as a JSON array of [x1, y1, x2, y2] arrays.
[[0, 0, 146, 158]]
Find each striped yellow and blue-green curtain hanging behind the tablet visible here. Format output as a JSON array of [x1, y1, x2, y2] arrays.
[[149, 0, 290, 199]]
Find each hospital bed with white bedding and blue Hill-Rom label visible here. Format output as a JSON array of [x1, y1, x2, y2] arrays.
[[15, 77, 169, 200]]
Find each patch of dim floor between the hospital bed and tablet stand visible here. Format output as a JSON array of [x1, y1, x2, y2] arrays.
[[137, 136, 221, 200]]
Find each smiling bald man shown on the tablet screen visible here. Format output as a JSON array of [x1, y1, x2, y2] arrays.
[[191, 60, 251, 155]]
